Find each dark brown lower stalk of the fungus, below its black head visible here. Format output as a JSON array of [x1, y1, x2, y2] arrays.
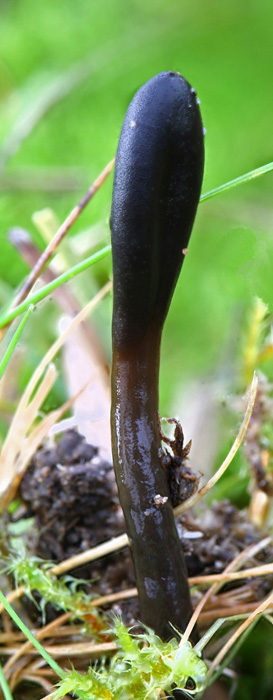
[[111, 333, 196, 639]]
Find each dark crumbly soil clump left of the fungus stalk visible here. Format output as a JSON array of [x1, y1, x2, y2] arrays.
[[17, 430, 134, 608]]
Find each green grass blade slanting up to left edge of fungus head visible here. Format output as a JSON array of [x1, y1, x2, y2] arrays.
[[0, 245, 111, 328]]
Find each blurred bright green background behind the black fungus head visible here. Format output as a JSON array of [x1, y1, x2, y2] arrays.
[[0, 0, 273, 404]]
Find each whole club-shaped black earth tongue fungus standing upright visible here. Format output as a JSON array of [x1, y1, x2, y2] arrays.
[[111, 72, 204, 639]]
